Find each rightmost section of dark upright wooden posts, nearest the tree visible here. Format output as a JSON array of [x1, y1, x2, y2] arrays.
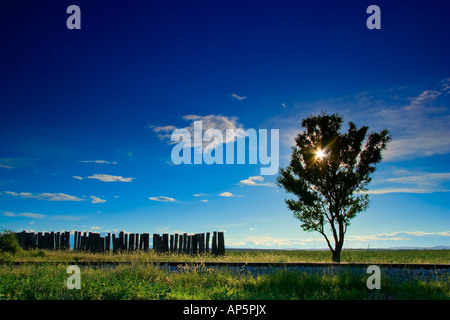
[[153, 231, 225, 255]]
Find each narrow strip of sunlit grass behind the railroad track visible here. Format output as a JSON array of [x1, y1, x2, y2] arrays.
[[0, 250, 450, 264]]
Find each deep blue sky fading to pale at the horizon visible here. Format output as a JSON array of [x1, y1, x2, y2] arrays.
[[0, 0, 450, 248]]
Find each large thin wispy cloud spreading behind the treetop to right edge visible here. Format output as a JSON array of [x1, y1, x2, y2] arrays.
[[270, 78, 450, 162]]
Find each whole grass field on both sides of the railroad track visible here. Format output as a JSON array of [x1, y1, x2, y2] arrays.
[[0, 250, 450, 300]]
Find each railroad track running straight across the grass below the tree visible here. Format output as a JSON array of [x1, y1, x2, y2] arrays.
[[0, 261, 450, 270]]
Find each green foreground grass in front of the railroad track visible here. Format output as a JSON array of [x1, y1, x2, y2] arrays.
[[0, 263, 450, 300]]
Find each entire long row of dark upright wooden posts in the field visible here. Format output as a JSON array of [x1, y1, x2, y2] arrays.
[[16, 231, 225, 255]]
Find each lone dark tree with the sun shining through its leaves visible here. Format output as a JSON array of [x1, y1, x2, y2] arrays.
[[278, 113, 391, 262]]
